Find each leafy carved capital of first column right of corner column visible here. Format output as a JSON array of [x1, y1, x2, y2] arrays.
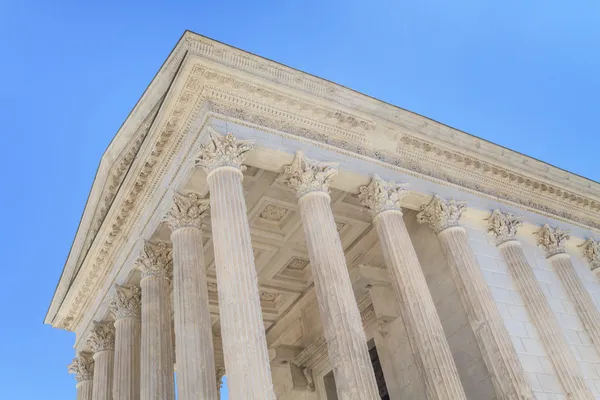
[[277, 151, 338, 198]]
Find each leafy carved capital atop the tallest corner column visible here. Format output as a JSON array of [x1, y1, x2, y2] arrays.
[[195, 133, 254, 173]]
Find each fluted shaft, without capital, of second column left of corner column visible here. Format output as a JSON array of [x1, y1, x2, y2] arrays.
[[141, 275, 175, 400]]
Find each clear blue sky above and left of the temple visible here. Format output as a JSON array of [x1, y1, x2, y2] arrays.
[[0, 0, 600, 400]]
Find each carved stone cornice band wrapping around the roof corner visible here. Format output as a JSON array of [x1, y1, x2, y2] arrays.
[[46, 33, 600, 330]]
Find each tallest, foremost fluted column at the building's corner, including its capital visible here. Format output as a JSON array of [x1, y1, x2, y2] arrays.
[[196, 134, 275, 400]]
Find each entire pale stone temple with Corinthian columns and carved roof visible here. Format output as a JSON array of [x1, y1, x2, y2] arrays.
[[45, 32, 600, 400]]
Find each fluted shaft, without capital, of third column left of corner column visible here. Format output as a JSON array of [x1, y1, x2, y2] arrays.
[[113, 315, 141, 400]]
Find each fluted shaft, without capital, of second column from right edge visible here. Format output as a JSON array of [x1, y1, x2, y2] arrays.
[[548, 253, 600, 353]]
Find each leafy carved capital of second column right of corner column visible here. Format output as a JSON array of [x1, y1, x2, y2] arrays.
[[358, 174, 410, 217]]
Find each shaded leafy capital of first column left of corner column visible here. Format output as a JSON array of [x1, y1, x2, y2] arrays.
[[165, 193, 210, 231]]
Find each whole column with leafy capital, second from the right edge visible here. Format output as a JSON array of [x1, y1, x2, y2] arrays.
[[537, 225, 600, 353]]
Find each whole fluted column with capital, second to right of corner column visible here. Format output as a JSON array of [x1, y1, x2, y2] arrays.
[[358, 175, 466, 400]]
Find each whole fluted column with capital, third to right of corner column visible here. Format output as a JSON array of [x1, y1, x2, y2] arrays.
[[417, 196, 533, 400]]
